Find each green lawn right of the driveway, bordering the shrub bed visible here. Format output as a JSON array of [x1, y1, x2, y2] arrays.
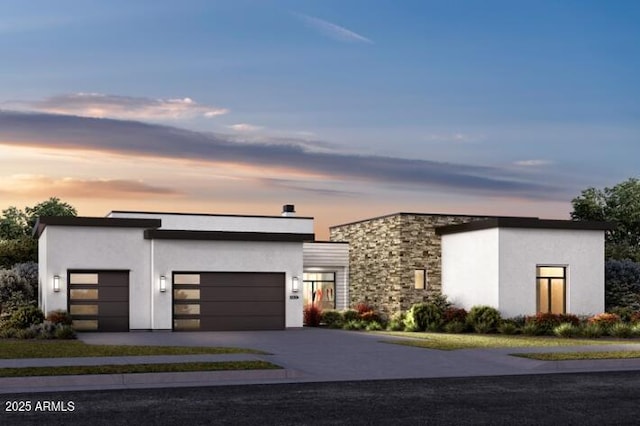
[[376, 331, 640, 351]]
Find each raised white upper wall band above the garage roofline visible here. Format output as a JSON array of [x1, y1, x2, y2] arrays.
[[108, 212, 313, 234]]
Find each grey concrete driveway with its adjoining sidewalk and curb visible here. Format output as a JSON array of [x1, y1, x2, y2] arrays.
[[0, 328, 640, 393]]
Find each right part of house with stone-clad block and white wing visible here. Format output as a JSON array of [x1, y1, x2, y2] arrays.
[[330, 213, 611, 316]]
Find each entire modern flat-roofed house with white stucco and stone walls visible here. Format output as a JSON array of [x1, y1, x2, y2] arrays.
[[34, 205, 609, 331]]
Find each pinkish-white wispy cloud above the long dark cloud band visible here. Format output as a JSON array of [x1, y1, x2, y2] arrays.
[[9, 93, 228, 120]]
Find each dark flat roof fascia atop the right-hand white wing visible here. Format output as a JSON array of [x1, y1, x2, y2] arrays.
[[436, 217, 614, 235]]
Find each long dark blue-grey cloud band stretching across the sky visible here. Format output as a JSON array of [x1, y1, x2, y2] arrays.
[[0, 111, 566, 199]]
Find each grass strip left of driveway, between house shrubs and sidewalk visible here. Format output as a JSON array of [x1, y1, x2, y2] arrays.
[[0, 339, 266, 359]]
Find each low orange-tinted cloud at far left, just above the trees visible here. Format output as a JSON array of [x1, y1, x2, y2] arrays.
[[1, 175, 180, 198]]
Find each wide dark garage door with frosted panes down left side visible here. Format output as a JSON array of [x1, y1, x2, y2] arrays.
[[173, 272, 285, 331]]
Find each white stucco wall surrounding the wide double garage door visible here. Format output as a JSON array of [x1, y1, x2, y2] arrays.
[[153, 240, 303, 329]]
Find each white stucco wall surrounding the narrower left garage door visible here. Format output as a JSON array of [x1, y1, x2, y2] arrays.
[[38, 226, 151, 329]]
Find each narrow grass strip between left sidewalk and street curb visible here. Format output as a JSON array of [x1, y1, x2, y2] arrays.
[[0, 361, 282, 377]]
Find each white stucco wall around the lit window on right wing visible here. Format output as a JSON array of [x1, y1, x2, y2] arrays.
[[500, 228, 604, 316]]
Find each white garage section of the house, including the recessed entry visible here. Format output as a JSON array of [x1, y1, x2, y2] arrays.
[[35, 205, 348, 331]]
